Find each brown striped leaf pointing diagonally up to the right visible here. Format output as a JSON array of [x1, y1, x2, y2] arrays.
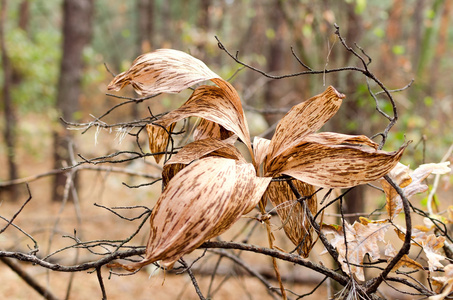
[[268, 86, 345, 160]]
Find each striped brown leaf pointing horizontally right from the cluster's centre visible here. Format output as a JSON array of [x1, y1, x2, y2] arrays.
[[265, 134, 405, 188]]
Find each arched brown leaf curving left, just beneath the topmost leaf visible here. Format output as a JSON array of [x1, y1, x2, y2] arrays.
[[156, 85, 252, 155]]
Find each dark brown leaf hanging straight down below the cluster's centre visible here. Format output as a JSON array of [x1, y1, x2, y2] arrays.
[[264, 180, 318, 257]]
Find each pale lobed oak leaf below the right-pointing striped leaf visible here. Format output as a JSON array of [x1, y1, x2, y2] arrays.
[[322, 222, 392, 281]]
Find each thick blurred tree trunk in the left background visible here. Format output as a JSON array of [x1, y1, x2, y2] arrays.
[[52, 0, 94, 201]]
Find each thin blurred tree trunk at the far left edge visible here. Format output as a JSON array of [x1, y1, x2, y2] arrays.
[[0, 0, 18, 200]]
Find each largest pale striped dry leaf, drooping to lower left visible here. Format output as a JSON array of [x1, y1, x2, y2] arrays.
[[123, 157, 271, 270]]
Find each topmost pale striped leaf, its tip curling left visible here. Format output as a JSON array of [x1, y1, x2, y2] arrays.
[[108, 49, 220, 95]]
